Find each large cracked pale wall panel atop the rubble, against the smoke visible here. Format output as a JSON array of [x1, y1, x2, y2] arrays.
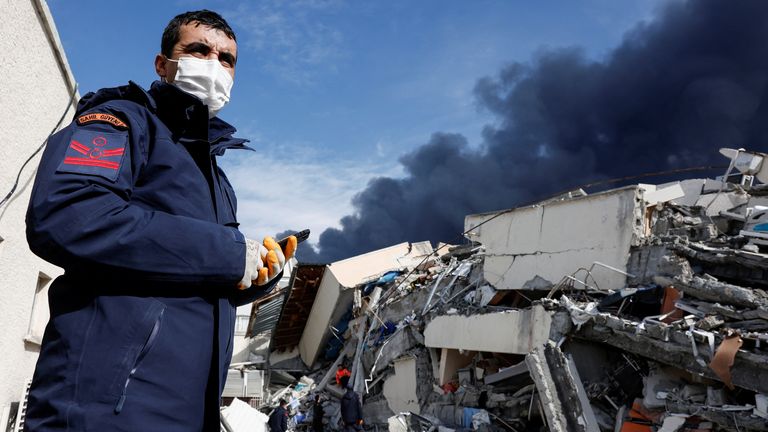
[[464, 186, 645, 290]]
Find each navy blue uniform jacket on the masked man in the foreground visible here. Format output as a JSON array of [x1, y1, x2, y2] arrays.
[[26, 82, 279, 432]]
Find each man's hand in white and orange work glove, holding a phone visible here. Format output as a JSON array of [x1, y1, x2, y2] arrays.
[[237, 236, 298, 290]]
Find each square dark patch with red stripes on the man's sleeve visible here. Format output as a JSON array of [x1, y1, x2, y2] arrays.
[[56, 129, 128, 181]]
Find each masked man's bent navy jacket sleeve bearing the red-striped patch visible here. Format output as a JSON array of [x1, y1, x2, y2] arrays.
[[26, 107, 245, 285]]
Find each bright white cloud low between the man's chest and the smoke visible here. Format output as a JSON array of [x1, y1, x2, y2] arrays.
[[216, 145, 401, 242]]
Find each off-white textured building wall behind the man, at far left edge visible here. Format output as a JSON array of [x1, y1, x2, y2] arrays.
[[0, 0, 74, 407]]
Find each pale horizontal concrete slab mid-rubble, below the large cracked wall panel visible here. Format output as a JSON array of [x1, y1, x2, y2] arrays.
[[424, 305, 552, 354]]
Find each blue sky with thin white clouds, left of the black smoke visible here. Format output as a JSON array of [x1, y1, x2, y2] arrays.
[[48, 0, 662, 243]]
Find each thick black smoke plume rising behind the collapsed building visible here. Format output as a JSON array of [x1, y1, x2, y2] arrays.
[[292, 0, 768, 262]]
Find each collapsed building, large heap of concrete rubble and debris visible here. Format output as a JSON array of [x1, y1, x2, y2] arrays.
[[225, 149, 768, 431]]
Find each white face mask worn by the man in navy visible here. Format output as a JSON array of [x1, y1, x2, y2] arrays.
[[168, 57, 234, 118]]
